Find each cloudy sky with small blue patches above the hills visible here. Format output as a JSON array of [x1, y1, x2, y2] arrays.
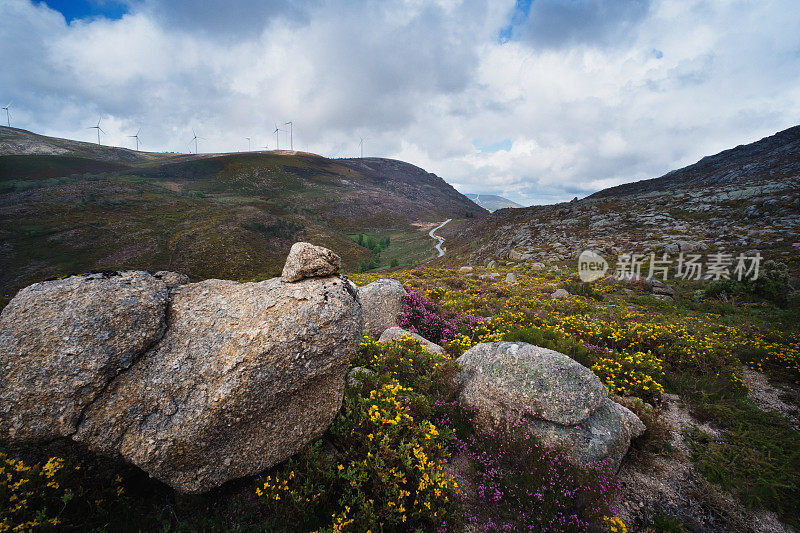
[[0, 0, 800, 205]]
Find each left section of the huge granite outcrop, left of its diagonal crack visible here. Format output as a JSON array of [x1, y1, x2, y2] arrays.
[[0, 272, 169, 440]]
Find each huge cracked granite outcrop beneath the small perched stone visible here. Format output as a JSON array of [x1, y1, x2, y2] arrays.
[[0, 243, 363, 493]]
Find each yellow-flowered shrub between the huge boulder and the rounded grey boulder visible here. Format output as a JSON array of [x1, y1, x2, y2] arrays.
[[256, 337, 459, 531]]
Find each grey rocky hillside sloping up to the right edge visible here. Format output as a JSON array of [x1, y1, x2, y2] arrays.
[[440, 126, 800, 271]]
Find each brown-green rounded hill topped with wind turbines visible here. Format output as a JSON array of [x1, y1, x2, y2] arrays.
[[0, 124, 487, 296]]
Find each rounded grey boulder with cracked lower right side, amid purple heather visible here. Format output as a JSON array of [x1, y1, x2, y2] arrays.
[[457, 342, 645, 467]]
